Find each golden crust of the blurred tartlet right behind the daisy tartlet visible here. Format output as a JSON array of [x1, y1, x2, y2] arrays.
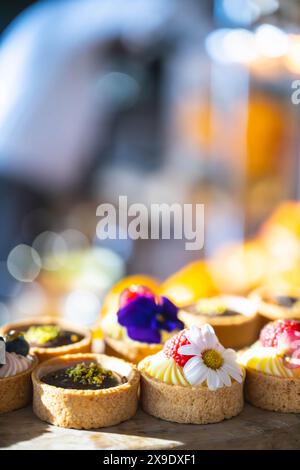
[[178, 295, 261, 349]]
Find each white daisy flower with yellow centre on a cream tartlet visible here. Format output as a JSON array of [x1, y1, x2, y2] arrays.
[[178, 324, 243, 390]]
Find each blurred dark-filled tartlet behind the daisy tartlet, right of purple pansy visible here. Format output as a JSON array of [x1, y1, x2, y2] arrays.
[[178, 295, 260, 349]]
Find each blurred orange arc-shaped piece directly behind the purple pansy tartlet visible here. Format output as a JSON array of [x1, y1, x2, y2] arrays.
[[101, 274, 159, 318]]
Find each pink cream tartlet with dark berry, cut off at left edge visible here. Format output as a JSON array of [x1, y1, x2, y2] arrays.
[[0, 332, 38, 413]]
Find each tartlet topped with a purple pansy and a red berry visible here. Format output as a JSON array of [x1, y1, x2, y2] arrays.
[[101, 285, 183, 363]]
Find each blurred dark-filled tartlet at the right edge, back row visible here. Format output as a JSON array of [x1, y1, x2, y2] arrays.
[[249, 286, 300, 323]]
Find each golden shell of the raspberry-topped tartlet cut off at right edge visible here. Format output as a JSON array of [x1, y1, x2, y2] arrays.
[[245, 369, 300, 413]]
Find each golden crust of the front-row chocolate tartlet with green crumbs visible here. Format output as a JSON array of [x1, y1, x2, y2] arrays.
[[32, 354, 140, 429]]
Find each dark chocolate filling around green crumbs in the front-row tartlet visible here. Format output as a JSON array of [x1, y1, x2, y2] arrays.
[[41, 367, 127, 390]]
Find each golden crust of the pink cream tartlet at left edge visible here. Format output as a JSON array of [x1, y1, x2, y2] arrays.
[[0, 356, 38, 413]]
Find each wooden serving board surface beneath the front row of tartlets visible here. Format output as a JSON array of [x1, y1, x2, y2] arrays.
[[0, 405, 300, 450]]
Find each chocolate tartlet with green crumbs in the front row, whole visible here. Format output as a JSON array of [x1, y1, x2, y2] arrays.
[[32, 354, 140, 429]]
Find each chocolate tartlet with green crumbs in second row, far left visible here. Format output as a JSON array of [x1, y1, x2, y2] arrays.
[[1, 317, 92, 362]]
